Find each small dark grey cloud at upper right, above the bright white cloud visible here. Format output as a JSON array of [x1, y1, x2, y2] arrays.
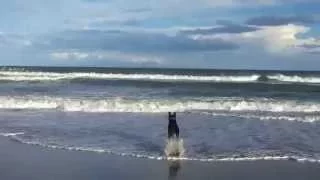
[[246, 16, 316, 26]]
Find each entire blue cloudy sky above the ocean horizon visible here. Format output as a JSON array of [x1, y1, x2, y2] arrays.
[[0, 0, 320, 70]]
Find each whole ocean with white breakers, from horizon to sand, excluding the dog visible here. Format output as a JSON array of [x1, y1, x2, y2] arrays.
[[0, 67, 320, 163]]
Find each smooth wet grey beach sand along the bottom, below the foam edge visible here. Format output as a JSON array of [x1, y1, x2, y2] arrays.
[[0, 137, 320, 180]]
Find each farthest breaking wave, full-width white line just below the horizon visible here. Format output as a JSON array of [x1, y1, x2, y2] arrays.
[[0, 70, 320, 84]]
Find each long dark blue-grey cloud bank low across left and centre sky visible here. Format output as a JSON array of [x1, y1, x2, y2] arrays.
[[43, 30, 237, 53]]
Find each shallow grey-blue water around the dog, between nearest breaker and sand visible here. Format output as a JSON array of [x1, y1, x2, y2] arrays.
[[0, 111, 320, 161]]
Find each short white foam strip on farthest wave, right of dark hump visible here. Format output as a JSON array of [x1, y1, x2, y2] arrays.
[[268, 74, 320, 84]]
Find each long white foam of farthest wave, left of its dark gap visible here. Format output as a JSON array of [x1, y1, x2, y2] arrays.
[[0, 71, 259, 82]]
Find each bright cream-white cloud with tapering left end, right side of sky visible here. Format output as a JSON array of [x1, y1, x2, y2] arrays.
[[190, 24, 319, 55]]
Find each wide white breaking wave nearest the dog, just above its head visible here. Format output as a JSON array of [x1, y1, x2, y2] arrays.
[[0, 96, 320, 113]]
